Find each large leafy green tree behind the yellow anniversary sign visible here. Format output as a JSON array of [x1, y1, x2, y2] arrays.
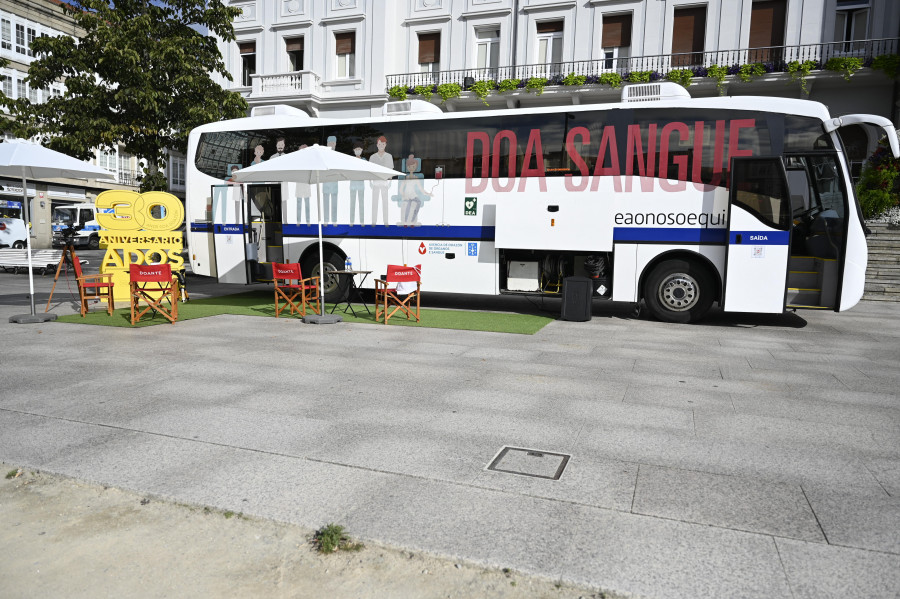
[[5, 0, 247, 191]]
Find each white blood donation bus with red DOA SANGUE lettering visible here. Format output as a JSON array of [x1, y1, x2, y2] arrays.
[[186, 83, 900, 322]]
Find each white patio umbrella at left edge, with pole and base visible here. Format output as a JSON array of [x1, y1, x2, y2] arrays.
[[0, 140, 115, 323]]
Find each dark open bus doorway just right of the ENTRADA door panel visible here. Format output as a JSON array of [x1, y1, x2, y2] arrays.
[[247, 183, 284, 281]]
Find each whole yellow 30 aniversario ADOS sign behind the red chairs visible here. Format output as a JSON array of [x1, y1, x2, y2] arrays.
[[94, 190, 184, 301]]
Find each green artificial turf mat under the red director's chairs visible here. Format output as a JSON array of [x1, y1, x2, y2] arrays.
[[56, 291, 553, 335]]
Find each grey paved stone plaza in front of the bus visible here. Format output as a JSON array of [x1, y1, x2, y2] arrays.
[[0, 260, 900, 599]]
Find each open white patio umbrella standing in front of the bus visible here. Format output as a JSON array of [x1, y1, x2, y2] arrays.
[[234, 144, 403, 322]]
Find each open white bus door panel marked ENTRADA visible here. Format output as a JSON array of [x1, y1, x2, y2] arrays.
[[212, 185, 249, 284]]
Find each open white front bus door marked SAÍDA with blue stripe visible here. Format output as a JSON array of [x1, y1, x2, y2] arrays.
[[723, 157, 791, 314]]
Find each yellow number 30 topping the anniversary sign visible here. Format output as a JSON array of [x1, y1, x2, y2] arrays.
[[95, 190, 184, 232]]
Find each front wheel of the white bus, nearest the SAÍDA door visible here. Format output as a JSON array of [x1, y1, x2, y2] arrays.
[[644, 259, 715, 323]]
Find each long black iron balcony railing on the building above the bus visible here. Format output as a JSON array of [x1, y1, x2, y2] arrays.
[[387, 38, 900, 93]]
